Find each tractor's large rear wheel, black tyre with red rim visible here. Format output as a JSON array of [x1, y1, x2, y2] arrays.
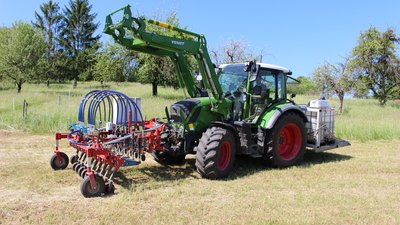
[[263, 113, 307, 167]]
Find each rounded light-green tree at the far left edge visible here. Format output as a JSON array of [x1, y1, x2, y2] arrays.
[[0, 22, 46, 93]]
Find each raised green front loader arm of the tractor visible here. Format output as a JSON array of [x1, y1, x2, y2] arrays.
[[104, 5, 223, 102]]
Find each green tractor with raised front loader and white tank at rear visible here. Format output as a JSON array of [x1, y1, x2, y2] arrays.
[[104, 5, 349, 179]]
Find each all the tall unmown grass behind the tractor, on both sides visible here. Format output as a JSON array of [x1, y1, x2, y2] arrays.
[[0, 82, 400, 141]]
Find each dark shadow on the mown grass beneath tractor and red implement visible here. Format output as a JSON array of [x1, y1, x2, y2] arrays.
[[114, 152, 352, 189]]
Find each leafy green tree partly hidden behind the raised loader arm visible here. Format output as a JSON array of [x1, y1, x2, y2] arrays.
[[137, 13, 193, 96]]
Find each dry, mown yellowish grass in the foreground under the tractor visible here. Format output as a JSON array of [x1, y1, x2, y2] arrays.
[[0, 131, 400, 224]]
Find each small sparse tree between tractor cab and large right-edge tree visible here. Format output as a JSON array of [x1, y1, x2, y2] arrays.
[[313, 63, 353, 113]]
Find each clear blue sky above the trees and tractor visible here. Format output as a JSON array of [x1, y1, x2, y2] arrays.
[[0, 0, 400, 77]]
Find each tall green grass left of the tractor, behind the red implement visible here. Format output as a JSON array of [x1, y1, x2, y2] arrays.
[[0, 83, 183, 133]]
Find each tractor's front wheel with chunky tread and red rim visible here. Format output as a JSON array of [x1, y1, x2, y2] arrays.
[[195, 127, 236, 179]]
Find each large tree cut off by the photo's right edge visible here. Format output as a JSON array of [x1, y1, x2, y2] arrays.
[[351, 27, 400, 105]]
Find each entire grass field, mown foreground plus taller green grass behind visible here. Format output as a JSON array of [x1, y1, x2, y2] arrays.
[[0, 83, 400, 224]]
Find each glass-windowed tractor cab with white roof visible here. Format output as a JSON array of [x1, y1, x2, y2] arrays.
[[218, 63, 291, 121]]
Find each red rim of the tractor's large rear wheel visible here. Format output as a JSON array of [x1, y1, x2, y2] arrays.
[[278, 123, 302, 161]]
